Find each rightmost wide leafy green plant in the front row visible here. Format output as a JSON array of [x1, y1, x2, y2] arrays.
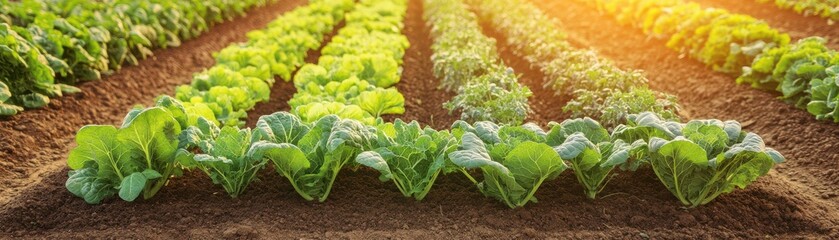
[[649, 120, 784, 207]]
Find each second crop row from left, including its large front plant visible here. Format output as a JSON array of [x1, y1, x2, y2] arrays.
[[66, 0, 353, 203]]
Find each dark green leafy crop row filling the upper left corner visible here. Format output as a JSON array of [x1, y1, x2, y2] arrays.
[[0, 0, 278, 116]]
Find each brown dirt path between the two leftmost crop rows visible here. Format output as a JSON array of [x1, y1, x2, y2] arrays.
[[0, 0, 306, 205]]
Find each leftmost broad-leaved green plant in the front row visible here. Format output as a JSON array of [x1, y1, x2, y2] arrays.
[[66, 107, 181, 204]]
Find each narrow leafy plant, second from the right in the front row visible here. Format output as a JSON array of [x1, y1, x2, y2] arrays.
[[547, 118, 630, 199]]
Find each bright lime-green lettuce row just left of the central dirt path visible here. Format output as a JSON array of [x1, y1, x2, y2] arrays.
[[288, 0, 409, 123]]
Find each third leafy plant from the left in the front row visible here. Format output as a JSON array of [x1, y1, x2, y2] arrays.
[[247, 112, 377, 202]]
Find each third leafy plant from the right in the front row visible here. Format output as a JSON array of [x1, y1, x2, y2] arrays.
[[449, 121, 568, 208]]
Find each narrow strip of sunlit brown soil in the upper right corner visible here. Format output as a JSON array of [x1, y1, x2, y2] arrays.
[[690, 0, 839, 49]]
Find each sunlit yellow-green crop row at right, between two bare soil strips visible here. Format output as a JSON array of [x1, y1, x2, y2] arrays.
[[583, 0, 839, 122]]
